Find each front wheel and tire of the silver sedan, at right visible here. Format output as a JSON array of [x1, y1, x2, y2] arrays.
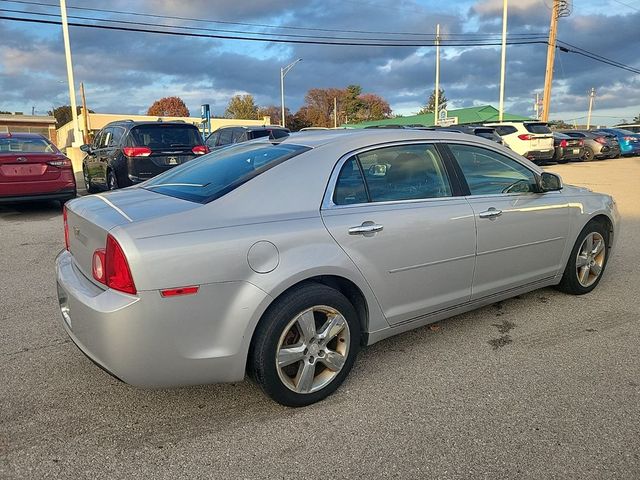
[[557, 221, 609, 295]]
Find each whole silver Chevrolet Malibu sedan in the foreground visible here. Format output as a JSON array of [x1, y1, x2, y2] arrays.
[[56, 130, 618, 406]]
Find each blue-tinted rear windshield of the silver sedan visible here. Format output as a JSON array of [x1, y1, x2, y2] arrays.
[[142, 142, 310, 203]]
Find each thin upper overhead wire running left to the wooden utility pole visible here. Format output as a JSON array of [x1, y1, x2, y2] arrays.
[[0, 0, 545, 38]]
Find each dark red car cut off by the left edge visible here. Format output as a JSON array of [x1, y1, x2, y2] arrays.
[[0, 133, 76, 203]]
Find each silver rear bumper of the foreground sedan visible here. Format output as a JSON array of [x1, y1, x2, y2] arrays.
[[56, 250, 268, 387]]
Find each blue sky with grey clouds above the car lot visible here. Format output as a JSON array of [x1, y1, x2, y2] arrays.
[[0, 0, 640, 124]]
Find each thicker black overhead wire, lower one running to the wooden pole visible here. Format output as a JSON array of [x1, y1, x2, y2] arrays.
[[0, 15, 546, 47]]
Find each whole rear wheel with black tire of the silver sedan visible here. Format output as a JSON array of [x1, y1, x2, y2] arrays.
[[250, 283, 360, 407]]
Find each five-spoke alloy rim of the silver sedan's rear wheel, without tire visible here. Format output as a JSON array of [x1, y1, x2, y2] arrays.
[[275, 305, 351, 394]]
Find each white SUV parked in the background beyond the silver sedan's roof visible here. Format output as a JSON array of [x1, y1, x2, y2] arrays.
[[485, 122, 553, 164]]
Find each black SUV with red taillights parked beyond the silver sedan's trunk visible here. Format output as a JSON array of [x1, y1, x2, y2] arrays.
[[80, 120, 209, 193]]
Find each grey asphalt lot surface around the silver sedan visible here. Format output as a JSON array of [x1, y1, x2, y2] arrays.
[[0, 158, 640, 480]]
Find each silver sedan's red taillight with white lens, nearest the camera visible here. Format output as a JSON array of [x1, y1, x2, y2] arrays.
[[91, 235, 137, 295]]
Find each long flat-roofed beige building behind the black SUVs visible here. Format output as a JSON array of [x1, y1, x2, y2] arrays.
[[55, 113, 271, 149]]
